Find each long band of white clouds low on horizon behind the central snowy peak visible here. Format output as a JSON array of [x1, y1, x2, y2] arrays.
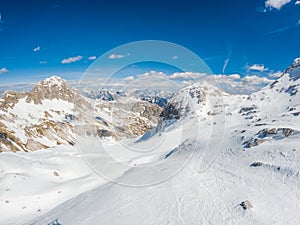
[[105, 71, 281, 94]]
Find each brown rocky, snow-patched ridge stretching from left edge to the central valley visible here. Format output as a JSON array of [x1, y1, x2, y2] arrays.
[[0, 76, 161, 152]]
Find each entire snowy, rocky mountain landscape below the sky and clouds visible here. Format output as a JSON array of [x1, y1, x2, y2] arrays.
[[0, 59, 300, 225]]
